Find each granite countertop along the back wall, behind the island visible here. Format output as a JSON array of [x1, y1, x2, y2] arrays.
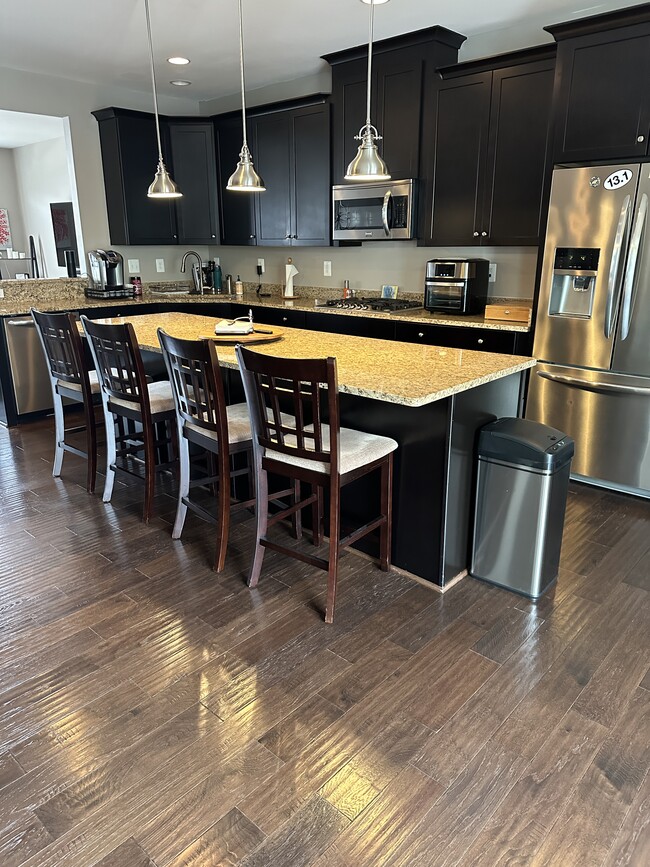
[[0, 278, 530, 333]]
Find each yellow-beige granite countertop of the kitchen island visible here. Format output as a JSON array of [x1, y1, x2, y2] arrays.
[[92, 313, 535, 406]]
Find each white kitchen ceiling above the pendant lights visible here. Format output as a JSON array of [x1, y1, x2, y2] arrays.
[[0, 0, 637, 102]]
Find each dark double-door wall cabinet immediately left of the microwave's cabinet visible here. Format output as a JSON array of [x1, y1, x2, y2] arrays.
[[251, 102, 331, 247]]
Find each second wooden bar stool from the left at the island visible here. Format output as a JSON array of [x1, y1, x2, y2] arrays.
[[81, 315, 176, 523]]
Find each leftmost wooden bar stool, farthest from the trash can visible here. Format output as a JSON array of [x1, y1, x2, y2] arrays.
[[30, 307, 100, 494]]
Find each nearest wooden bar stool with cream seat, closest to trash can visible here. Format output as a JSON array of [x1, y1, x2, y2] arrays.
[[236, 345, 397, 623]]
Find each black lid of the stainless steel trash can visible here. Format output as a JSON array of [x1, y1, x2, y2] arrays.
[[478, 418, 575, 471]]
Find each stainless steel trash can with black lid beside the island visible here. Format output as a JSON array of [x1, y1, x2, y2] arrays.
[[470, 418, 574, 599]]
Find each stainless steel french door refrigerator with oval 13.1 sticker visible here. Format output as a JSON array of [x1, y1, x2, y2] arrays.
[[526, 163, 650, 497]]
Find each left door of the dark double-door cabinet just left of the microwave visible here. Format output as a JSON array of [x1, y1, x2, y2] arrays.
[[252, 111, 293, 246]]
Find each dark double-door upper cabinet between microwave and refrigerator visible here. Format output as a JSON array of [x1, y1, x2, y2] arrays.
[[420, 46, 555, 246]]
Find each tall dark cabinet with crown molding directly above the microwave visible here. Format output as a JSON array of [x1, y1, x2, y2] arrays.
[[323, 27, 465, 184]]
